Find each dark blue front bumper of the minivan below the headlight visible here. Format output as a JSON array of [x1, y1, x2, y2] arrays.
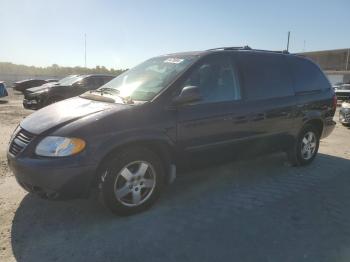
[[7, 153, 96, 200]]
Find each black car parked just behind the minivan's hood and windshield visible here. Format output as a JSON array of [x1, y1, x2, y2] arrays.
[[23, 74, 115, 109]]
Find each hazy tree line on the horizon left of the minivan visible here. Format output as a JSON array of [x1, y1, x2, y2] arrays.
[[0, 62, 125, 77]]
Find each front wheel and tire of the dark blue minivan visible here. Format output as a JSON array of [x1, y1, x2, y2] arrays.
[[99, 147, 164, 216]]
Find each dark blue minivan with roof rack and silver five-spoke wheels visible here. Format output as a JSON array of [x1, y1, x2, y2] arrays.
[[8, 47, 336, 215]]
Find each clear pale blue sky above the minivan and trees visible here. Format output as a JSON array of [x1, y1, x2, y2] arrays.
[[0, 0, 350, 69]]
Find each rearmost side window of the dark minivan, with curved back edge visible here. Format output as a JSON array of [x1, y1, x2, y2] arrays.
[[288, 56, 330, 93]]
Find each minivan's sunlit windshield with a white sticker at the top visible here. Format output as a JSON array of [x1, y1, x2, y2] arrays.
[[99, 55, 197, 101]]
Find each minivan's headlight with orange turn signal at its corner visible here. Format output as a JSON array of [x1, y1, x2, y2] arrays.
[[35, 136, 86, 157]]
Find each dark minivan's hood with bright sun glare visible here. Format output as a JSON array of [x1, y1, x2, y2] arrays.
[[20, 97, 121, 135]]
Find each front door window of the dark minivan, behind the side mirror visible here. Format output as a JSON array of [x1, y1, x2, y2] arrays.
[[182, 56, 241, 103]]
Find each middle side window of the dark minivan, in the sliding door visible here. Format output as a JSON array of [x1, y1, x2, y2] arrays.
[[239, 53, 294, 100]]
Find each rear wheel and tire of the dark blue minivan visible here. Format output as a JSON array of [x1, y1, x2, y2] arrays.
[[287, 125, 320, 166]]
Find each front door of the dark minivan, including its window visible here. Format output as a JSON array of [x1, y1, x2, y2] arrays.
[[177, 54, 246, 151]]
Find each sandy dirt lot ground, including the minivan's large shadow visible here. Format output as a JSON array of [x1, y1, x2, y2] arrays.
[[0, 88, 350, 262]]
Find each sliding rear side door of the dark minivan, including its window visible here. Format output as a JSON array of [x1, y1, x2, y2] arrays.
[[239, 52, 296, 144]]
